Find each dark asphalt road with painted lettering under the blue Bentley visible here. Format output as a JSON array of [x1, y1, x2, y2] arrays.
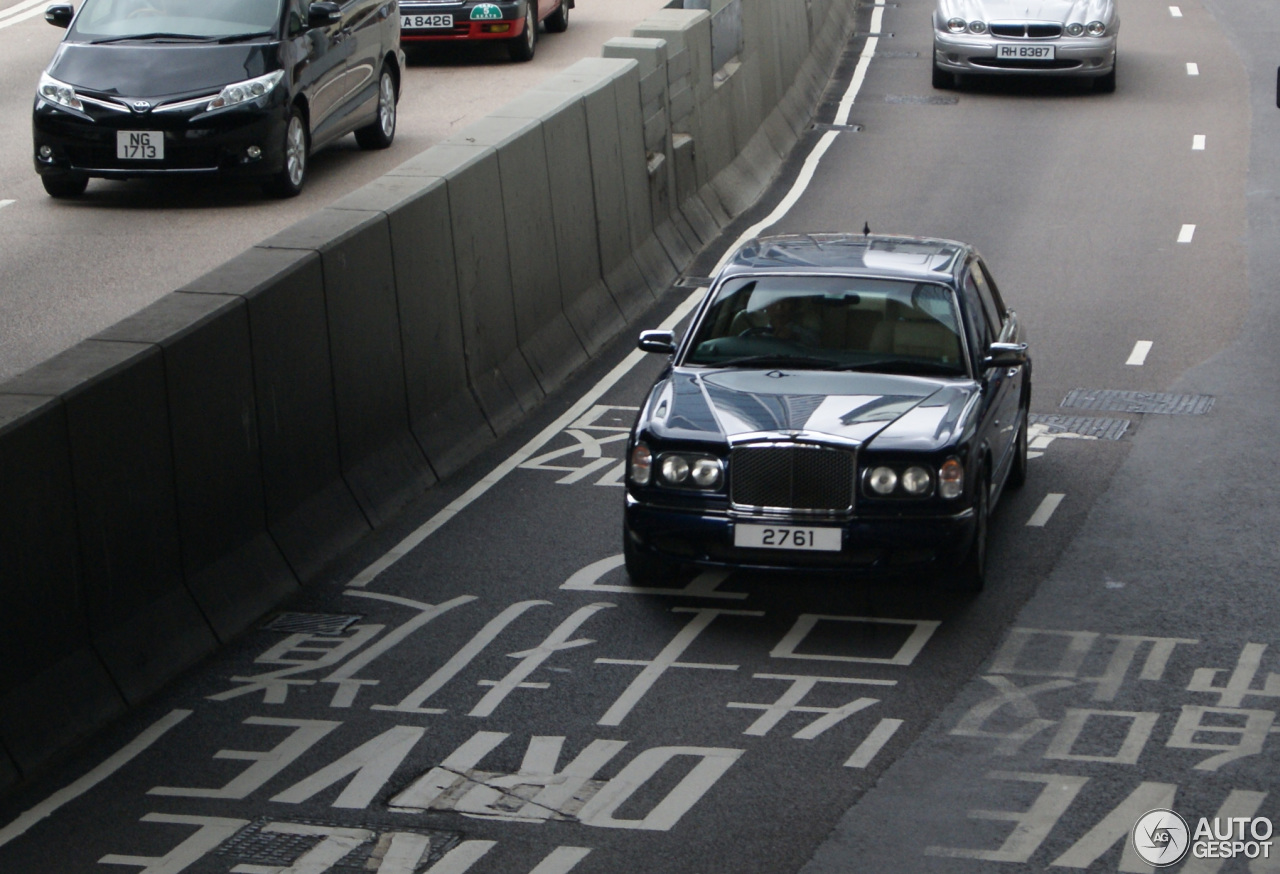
[[0, 0, 1280, 874]]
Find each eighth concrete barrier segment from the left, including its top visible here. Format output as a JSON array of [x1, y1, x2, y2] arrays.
[[445, 116, 588, 393]]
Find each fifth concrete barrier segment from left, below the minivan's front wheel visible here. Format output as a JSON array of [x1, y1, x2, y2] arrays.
[[260, 209, 435, 527]]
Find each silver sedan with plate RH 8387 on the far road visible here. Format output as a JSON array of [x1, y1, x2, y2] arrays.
[[933, 0, 1120, 93]]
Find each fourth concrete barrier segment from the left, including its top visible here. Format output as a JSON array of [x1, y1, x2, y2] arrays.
[[182, 248, 370, 582]]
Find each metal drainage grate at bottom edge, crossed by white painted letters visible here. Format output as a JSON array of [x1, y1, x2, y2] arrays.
[[215, 818, 462, 871]]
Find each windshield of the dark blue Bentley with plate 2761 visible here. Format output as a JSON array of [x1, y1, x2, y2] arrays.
[[684, 276, 966, 376]]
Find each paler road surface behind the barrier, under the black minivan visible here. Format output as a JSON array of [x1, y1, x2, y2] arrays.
[[0, 0, 667, 380]]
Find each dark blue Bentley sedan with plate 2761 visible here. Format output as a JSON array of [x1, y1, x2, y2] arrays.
[[623, 234, 1032, 590]]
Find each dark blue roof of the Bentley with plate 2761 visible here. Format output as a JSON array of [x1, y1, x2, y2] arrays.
[[721, 233, 973, 282]]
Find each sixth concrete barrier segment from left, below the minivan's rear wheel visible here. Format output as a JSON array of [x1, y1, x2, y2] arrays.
[[332, 175, 495, 479]]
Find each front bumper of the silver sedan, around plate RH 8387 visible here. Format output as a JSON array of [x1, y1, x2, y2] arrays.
[[933, 31, 1117, 77]]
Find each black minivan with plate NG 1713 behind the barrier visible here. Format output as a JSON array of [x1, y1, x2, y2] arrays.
[[32, 0, 404, 197]]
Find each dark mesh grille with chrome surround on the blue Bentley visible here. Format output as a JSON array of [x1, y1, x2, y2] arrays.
[[728, 444, 856, 513]]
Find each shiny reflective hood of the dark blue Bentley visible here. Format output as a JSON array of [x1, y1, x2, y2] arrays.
[[649, 369, 978, 450]]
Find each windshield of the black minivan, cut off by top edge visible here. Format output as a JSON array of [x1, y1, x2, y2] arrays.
[[72, 0, 284, 42]]
